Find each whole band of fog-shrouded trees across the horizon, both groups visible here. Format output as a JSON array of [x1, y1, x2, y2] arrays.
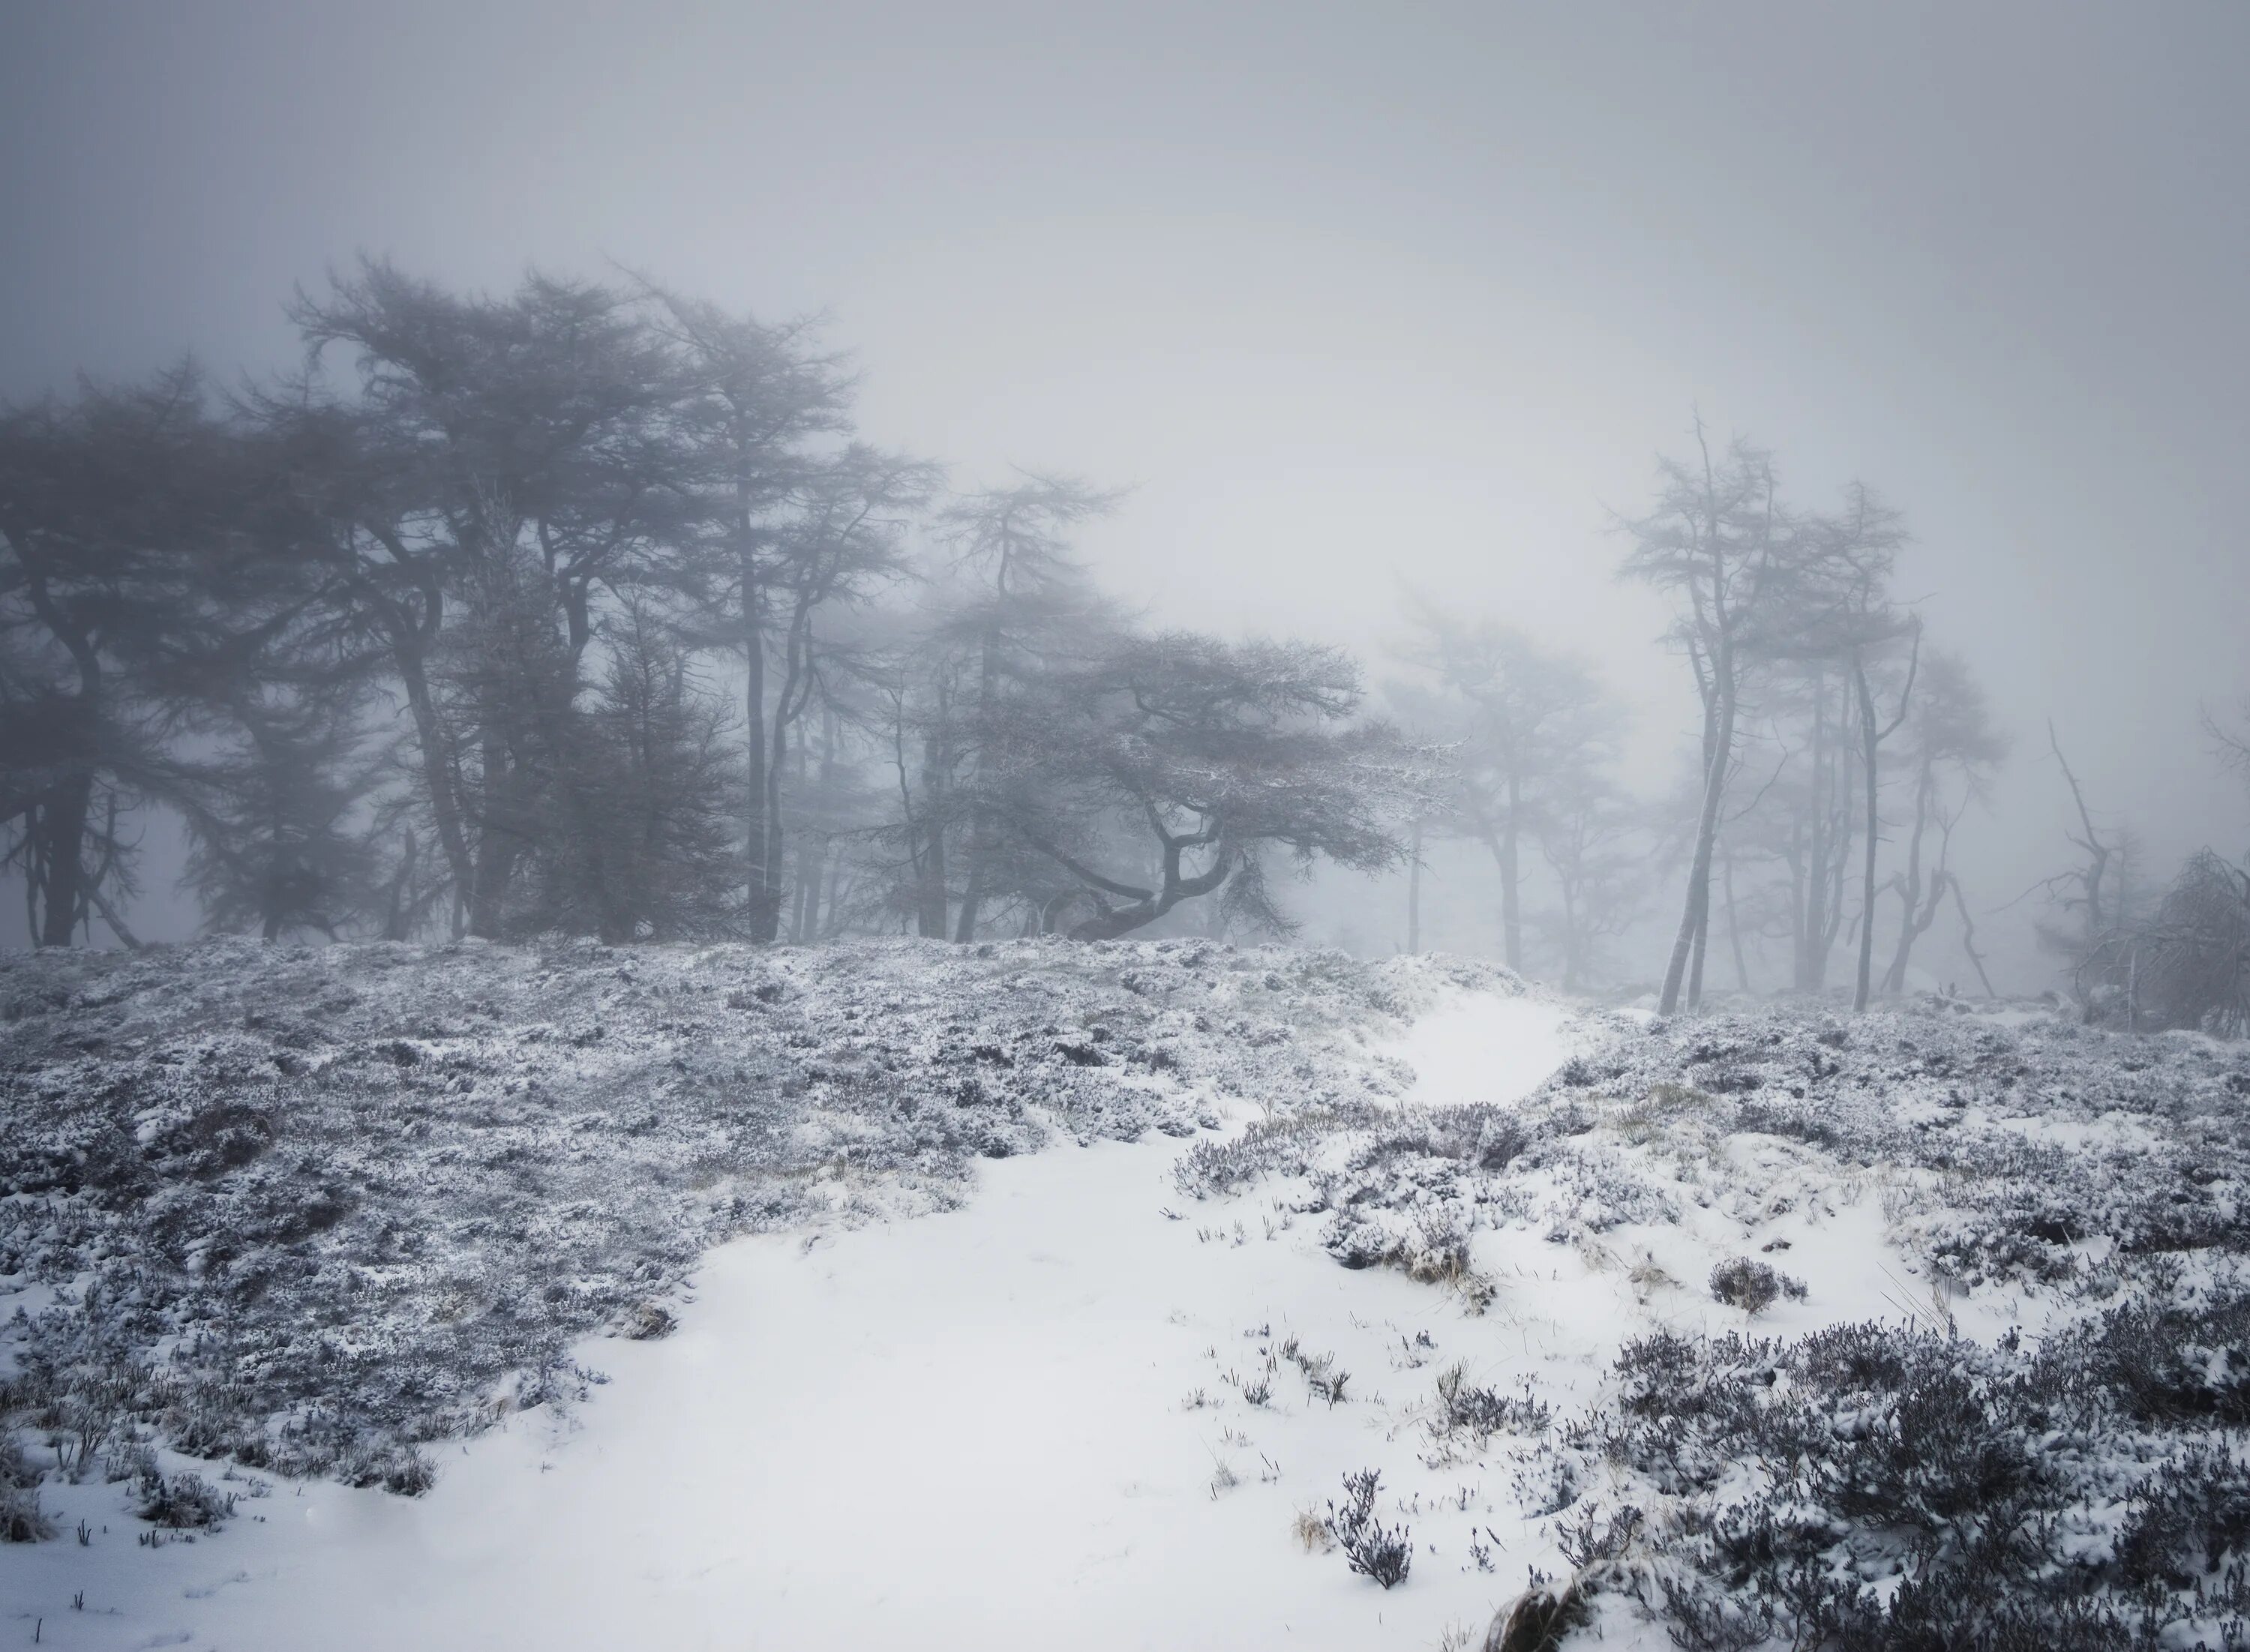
[[0, 261, 2250, 1033]]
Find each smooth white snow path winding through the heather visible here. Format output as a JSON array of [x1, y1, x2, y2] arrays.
[[13, 995, 1618, 1652]]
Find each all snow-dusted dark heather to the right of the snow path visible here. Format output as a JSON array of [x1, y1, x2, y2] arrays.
[[1179, 1002, 2250, 1650]]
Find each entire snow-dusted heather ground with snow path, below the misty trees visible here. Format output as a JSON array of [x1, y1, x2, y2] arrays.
[[0, 943, 2250, 1652]]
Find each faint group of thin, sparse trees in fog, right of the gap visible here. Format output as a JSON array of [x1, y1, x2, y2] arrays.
[[1395, 427, 2007, 1015]]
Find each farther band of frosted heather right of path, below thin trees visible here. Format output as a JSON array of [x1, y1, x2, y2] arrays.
[[1174, 1006, 2250, 1303]]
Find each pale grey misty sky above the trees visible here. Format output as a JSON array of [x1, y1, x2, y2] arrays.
[[0, 0, 2250, 972]]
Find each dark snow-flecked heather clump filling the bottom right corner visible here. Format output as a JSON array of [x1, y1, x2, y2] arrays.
[[1566, 1297, 2250, 1652]]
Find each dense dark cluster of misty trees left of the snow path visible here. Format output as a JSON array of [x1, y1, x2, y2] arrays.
[[0, 263, 1426, 946]]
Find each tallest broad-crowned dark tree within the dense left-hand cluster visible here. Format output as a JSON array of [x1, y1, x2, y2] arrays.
[[284, 263, 700, 937]]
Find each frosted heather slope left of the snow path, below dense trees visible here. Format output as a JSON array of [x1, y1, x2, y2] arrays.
[[0, 941, 1438, 1503]]
